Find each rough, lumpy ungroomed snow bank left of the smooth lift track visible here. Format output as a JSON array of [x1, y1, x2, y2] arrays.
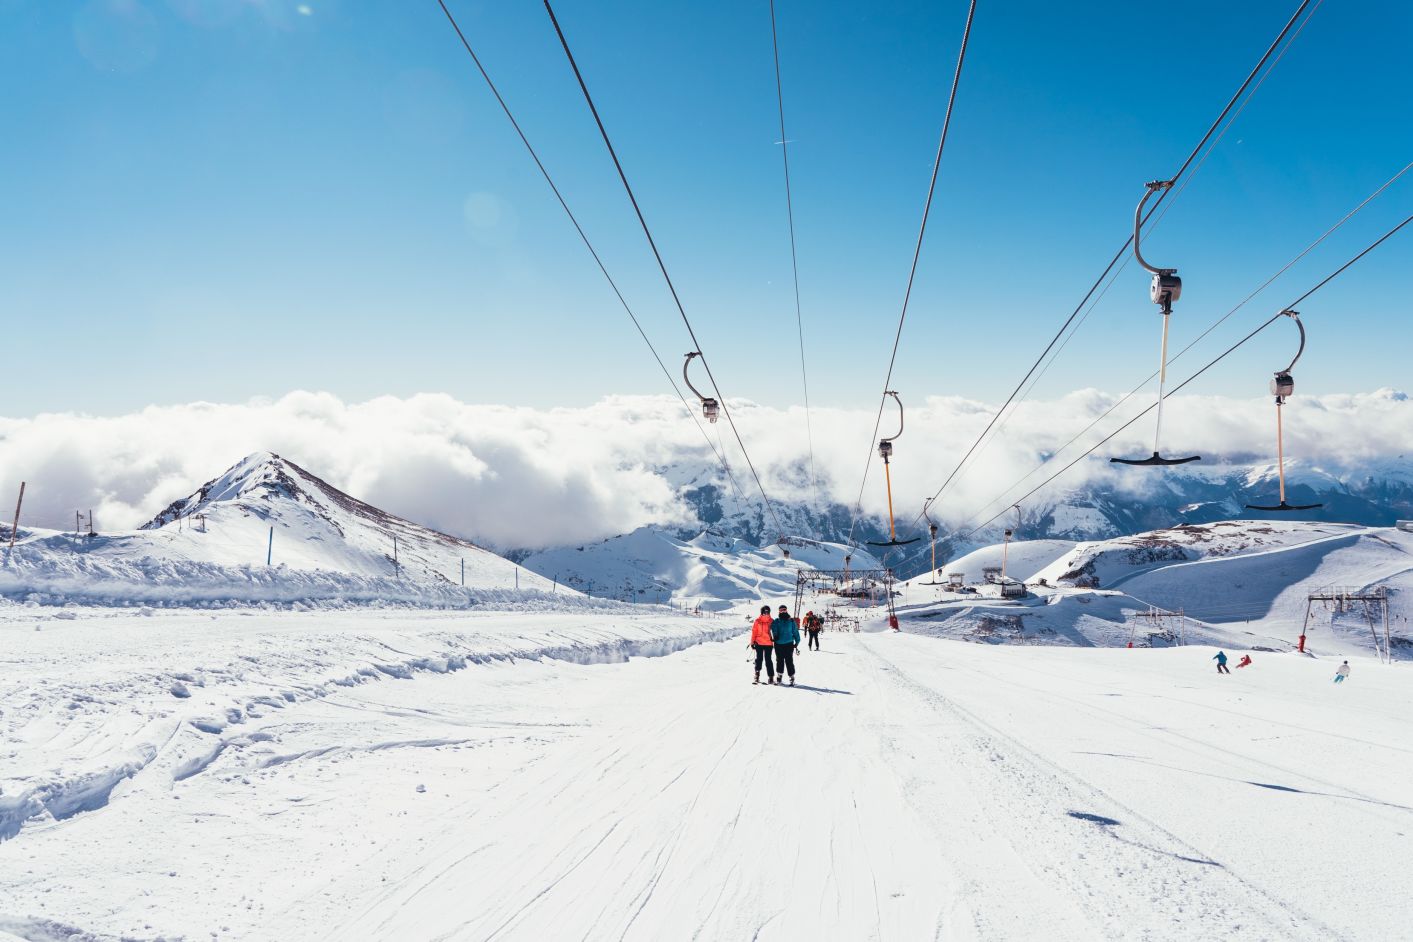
[[0, 593, 738, 853]]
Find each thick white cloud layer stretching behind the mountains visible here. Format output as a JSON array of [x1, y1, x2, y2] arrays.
[[0, 390, 1413, 548]]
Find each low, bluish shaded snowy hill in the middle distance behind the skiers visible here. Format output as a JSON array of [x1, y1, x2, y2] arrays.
[[523, 527, 877, 610]]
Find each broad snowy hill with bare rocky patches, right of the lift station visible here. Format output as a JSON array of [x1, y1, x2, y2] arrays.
[[900, 521, 1413, 654]]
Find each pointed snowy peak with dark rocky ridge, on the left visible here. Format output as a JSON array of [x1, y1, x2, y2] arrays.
[[0, 452, 552, 604]]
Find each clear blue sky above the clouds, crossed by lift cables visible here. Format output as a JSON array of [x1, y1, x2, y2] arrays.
[[0, 0, 1413, 415]]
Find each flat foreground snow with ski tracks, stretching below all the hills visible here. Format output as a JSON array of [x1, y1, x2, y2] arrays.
[[0, 596, 1413, 942]]
